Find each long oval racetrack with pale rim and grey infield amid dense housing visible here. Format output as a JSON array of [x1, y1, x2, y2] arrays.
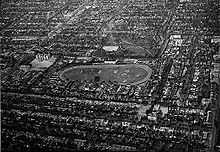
[[60, 64, 152, 85]]
